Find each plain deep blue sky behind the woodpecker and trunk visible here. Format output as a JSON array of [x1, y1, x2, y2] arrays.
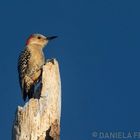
[[0, 0, 140, 140]]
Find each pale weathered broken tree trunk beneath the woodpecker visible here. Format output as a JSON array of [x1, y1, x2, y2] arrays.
[[12, 59, 61, 140]]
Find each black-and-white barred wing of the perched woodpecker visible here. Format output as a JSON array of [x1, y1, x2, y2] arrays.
[[18, 48, 31, 97]]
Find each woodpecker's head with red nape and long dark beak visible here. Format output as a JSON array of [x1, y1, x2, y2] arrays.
[[26, 34, 57, 48]]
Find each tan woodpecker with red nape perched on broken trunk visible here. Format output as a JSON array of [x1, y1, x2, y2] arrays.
[[18, 33, 57, 101]]
